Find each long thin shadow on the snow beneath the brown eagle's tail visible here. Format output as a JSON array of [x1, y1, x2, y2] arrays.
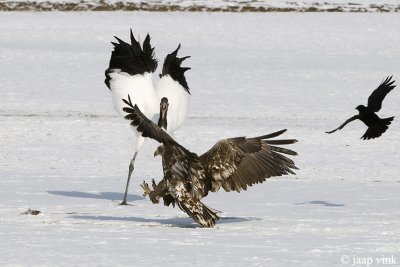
[[69, 215, 261, 228]]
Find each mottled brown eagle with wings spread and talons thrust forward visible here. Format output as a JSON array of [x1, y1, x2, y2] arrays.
[[123, 96, 297, 227]]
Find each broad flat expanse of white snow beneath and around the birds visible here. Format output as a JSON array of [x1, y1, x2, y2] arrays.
[[0, 13, 400, 266]]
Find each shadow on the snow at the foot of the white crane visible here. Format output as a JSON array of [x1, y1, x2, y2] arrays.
[[47, 191, 144, 202]]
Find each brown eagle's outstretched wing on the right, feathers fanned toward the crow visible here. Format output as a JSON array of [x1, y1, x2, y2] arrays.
[[200, 130, 297, 192]]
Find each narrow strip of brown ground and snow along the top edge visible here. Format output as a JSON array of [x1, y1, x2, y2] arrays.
[[0, 0, 400, 12]]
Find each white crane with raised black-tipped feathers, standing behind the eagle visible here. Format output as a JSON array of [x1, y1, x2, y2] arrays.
[[105, 30, 190, 205]]
